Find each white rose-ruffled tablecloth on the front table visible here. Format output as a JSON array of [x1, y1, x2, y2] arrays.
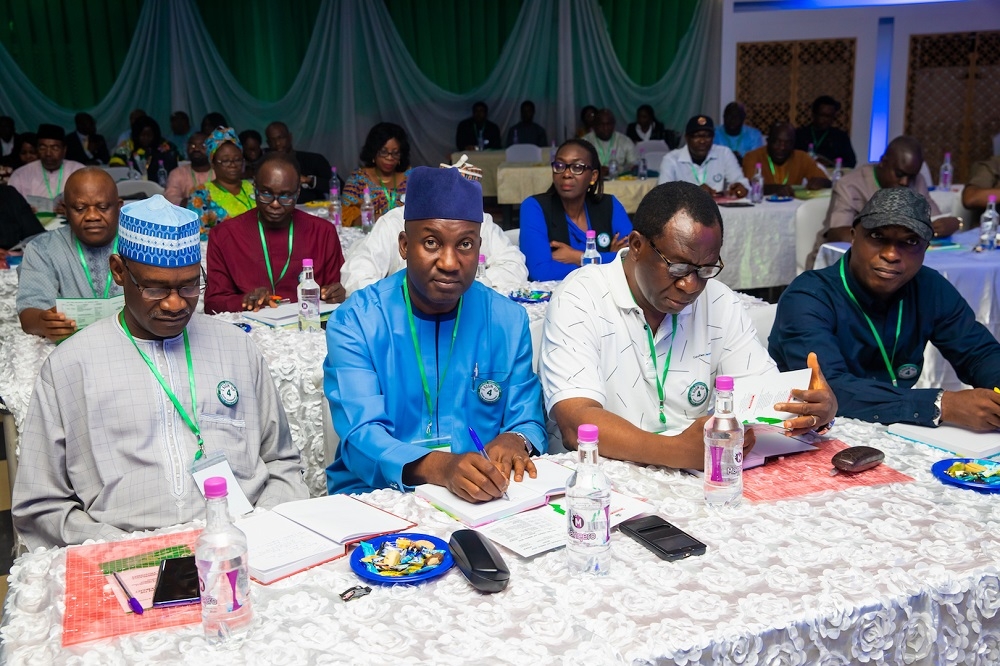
[[0, 420, 1000, 666]]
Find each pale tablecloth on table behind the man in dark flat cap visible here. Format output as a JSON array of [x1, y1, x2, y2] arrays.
[[816, 231, 1000, 391]]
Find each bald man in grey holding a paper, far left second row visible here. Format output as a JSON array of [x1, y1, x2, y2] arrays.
[[16, 167, 122, 342]]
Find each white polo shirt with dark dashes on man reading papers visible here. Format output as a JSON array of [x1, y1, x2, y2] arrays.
[[539, 248, 778, 432]]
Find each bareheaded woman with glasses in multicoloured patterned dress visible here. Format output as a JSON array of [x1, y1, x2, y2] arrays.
[[341, 123, 410, 226]]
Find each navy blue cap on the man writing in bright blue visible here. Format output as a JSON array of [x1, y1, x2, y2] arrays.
[[403, 167, 483, 224]]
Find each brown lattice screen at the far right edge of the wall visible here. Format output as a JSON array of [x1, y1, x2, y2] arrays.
[[904, 32, 1000, 182]]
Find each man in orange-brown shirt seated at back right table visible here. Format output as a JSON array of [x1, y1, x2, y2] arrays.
[[744, 123, 830, 197]]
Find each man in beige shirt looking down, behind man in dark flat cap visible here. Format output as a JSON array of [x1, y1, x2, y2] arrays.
[[806, 136, 961, 268]]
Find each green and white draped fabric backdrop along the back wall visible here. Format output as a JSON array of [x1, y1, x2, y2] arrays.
[[0, 0, 722, 176]]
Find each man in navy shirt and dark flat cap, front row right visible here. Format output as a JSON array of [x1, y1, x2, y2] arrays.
[[768, 187, 1000, 430]]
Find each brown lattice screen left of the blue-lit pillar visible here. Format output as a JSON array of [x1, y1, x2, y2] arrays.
[[736, 39, 855, 134]]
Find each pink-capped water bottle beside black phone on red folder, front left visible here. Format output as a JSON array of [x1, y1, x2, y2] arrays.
[[194, 476, 253, 650]]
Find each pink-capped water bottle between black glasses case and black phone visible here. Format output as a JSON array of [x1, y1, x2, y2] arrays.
[[566, 424, 611, 575]]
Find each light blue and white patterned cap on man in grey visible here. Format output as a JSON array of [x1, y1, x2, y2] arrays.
[[118, 194, 201, 268]]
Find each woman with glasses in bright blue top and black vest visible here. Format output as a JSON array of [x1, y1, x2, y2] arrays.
[[520, 139, 632, 280]]
